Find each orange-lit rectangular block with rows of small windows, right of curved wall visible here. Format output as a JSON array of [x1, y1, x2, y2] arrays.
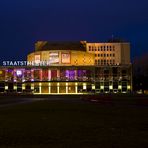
[[86, 43, 130, 65]]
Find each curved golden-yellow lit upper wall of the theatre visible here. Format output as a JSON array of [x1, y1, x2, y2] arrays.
[[27, 50, 95, 66]]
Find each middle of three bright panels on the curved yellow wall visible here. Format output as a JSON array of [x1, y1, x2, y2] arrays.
[[49, 52, 59, 64]]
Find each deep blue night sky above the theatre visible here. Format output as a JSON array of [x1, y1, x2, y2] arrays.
[[0, 0, 148, 61]]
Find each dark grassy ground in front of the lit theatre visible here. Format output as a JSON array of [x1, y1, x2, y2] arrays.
[[0, 96, 148, 148]]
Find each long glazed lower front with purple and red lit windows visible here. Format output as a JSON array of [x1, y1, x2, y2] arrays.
[[0, 65, 132, 94]]
